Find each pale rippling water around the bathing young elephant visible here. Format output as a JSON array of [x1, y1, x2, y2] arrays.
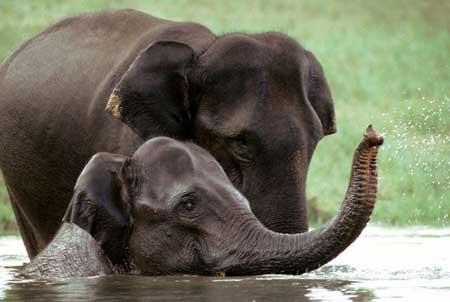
[[0, 227, 450, 302]]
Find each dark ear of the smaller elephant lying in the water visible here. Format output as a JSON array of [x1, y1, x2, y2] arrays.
[[63, 153, 131, 264]]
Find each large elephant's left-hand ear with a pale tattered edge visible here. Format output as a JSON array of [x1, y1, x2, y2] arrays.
[[106, 41, 195, 139]]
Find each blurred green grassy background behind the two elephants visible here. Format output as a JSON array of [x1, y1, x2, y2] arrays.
[[0, 0, 450, 232]]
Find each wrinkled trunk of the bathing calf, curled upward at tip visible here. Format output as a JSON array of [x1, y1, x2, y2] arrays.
[[221, 126, 383, 275]]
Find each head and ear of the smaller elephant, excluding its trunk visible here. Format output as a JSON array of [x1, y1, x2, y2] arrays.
[[64, 137, 255, 275]]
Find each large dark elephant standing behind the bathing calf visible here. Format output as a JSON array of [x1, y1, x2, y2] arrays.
[[0, 10, 336, 258]]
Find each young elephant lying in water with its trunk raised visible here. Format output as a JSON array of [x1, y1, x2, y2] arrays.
[[23, 127, 383, 278]]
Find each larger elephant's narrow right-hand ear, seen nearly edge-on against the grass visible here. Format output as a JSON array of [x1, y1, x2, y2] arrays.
[[306, 51, 337, 135]]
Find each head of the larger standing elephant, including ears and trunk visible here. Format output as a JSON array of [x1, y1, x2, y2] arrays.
[[107, 33, 336, 233]]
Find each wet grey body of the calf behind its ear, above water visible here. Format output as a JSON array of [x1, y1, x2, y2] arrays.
[[20, 222, 114, 279]]
